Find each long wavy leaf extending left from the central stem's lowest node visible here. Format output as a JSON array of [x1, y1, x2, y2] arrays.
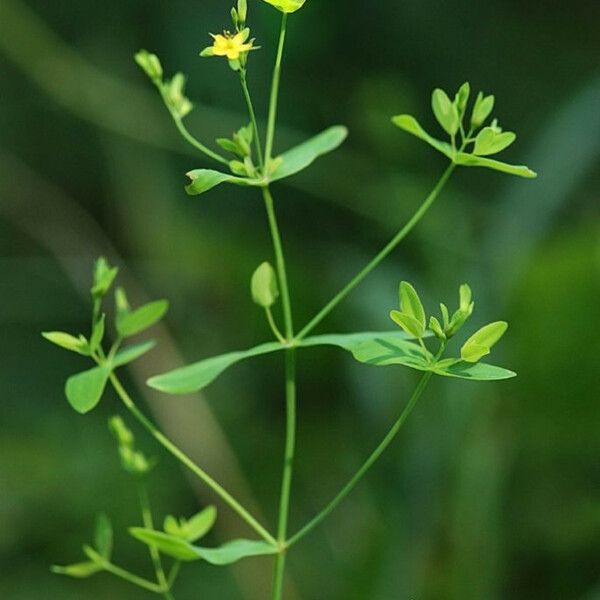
[[129, 527, 277, 566]]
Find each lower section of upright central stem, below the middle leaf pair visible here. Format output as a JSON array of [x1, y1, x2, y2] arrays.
[[273, 348, 296, 600]]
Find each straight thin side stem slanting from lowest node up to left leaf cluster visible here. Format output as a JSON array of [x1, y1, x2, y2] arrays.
[[110, 373, 277, 545]]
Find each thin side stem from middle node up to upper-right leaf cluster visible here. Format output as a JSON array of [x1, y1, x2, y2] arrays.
[[296, 163, 456, 340]]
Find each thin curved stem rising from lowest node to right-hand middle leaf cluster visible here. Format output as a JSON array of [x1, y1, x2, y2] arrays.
[[286, 372, 432, 548]]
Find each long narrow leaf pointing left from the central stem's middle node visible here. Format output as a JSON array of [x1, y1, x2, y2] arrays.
[[148, 342, 284, 394]]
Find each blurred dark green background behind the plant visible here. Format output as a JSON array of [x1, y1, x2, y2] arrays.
[[0, 0, 600, 600]]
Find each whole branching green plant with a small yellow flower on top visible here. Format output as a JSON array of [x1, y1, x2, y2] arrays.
[[43, 0, 536, 600]]
